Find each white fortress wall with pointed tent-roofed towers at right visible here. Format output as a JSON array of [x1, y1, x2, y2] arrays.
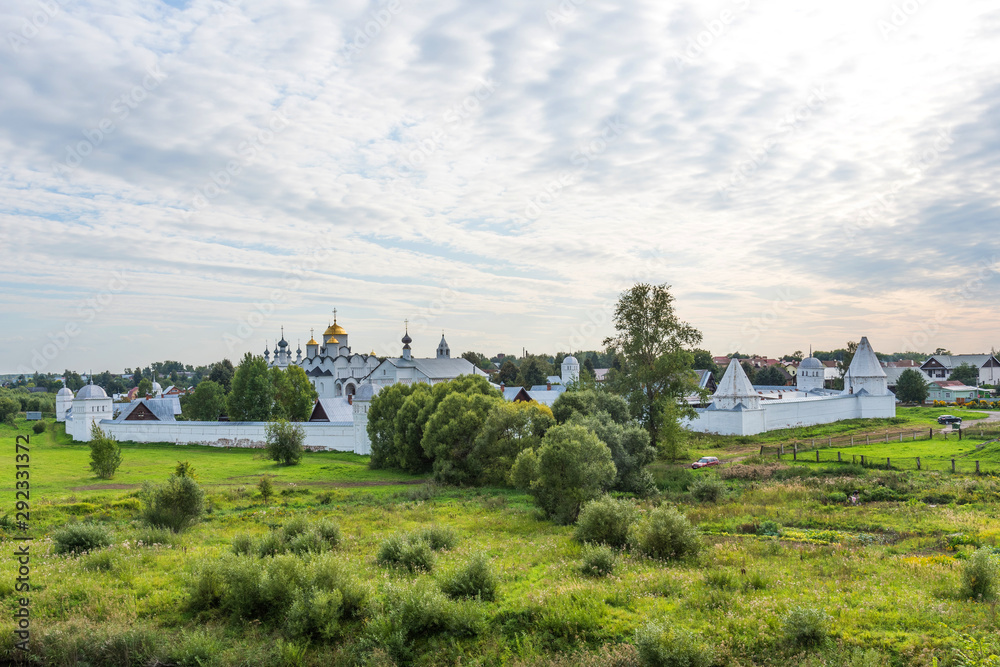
[[684, 337, 896, 435]]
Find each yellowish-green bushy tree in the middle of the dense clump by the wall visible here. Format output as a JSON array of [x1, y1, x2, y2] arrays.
[[420, 392, 503, 485]]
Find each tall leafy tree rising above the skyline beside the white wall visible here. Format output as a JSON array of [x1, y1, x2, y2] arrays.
[[604, 283, 701, 446]]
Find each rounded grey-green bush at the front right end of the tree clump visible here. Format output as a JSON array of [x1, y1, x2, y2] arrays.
[[511, 424, 617, 524]]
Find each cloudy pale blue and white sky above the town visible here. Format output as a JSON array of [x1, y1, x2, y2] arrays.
[[0, 0, 1000, 373]]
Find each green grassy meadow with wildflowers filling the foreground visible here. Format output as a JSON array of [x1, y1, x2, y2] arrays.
[[0, 408, 1000, 667]]
